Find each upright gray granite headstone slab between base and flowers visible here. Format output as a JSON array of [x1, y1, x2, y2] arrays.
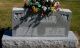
[[12, 8, 71, 37]]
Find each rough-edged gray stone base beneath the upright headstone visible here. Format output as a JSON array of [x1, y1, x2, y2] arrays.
[[2, 31, 78, 48]]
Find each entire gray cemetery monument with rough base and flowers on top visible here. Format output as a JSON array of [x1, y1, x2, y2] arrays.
[[3, 0, 78, 48]]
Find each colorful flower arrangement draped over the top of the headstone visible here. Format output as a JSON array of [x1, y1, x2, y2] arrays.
[[24, 0, 61, 16]]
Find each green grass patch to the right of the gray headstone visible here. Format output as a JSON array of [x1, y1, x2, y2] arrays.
[[60, 0, 80, 33]]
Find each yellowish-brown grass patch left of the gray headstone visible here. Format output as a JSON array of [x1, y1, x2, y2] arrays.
[[0, 0, 23, 28]]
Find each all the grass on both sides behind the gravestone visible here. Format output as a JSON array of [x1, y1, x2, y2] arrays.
[[0, 0, 80, 32]]
